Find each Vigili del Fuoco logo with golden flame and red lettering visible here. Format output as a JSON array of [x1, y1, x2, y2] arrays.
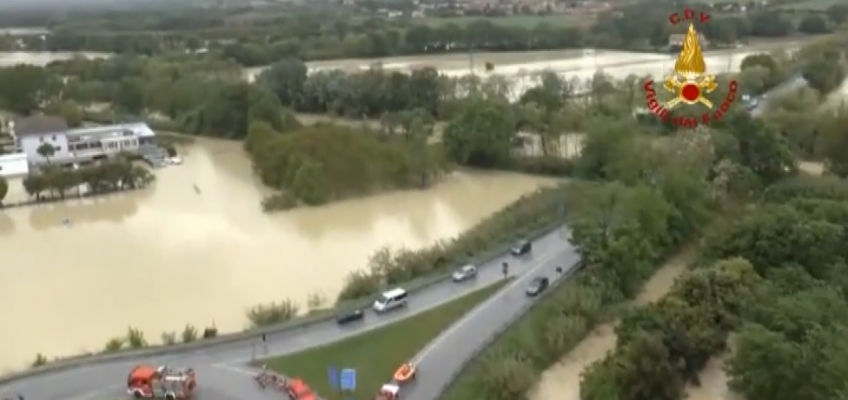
[[642, 9, 738, 128]]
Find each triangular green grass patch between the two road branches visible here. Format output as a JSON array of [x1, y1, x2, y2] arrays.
[[257, 281, 508, 400]]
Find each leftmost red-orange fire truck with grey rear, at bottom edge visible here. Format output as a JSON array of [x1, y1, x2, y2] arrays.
[[127, 365, 197, 400]]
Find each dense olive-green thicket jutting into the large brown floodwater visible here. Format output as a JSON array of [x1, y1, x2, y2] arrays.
[[244, 114, 450, 211]]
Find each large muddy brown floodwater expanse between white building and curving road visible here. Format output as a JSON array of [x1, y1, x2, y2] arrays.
[[0, 136, 553, 369]]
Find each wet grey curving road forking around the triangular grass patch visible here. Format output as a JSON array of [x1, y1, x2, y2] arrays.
[[0, 228, 579, 400]]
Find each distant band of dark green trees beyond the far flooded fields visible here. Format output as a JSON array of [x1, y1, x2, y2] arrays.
[[7, 3, 848, 66]]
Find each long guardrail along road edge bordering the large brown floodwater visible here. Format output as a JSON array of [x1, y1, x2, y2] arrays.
[[0, 219, 563, 385]]
